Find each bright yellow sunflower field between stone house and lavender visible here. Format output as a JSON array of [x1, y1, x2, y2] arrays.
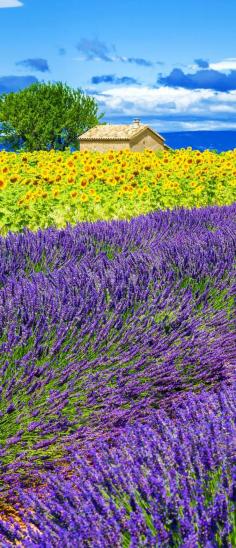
[[0, 149, 236, 235]]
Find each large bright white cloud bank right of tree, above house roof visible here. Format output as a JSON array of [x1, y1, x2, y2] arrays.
[[89, 85, 236, 131]]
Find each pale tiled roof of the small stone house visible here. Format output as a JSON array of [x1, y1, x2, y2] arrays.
[[79, 124, 165, 141]]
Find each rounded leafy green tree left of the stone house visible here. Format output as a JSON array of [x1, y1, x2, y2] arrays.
[[0, 82, 103, 151]]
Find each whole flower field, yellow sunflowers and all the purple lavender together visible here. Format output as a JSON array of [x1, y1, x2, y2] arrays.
[[0, 149, 236, 548]]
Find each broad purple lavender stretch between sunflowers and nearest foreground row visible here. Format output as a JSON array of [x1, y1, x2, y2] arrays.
[[0, 205, 236, 490]]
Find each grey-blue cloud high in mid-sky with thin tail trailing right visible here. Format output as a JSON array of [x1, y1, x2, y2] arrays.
[[76, 38, 157, 67]]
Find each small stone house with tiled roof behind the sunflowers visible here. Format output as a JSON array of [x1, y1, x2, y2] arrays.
[[79, 119, 170, 152]]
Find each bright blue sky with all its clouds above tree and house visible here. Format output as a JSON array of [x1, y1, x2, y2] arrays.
[[0, 0, 236, 131]]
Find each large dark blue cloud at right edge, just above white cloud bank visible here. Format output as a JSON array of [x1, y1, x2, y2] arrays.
[[157, 68, 236, 92]]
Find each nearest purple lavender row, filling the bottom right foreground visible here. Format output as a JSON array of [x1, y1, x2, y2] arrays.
[[0, 386, 236, 548]]
